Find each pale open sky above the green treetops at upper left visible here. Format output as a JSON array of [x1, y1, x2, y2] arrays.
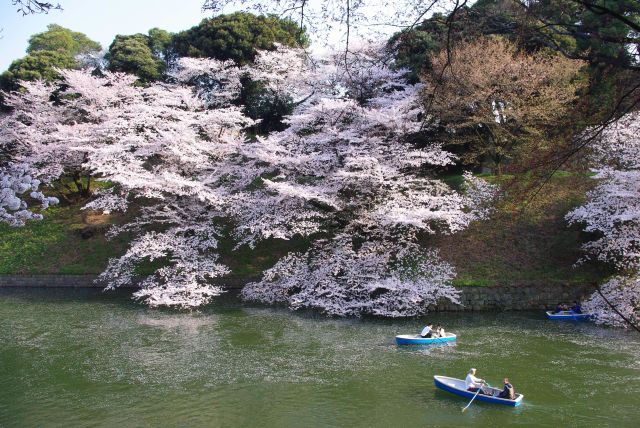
[[0, 0, 210, 72]]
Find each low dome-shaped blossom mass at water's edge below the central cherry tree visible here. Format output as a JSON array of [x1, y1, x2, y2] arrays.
[[242, 233, 459, 317]]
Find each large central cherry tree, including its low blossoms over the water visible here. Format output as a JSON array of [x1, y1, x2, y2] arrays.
[[235, 48, 495, 316]]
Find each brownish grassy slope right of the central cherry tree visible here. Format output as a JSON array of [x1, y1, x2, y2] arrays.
[[427, 172, 608, 286]]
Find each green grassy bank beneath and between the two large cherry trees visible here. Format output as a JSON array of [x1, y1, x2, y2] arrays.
[[0, 199, 306, 277]]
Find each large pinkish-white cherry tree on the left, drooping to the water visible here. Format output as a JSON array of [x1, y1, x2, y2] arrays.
[[0, 60, 252, 307]]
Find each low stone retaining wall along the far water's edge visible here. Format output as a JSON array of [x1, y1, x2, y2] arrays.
[[0, 275, 595, 311]]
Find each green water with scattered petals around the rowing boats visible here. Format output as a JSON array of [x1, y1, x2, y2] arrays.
[[0, 290, 640, 428]]
